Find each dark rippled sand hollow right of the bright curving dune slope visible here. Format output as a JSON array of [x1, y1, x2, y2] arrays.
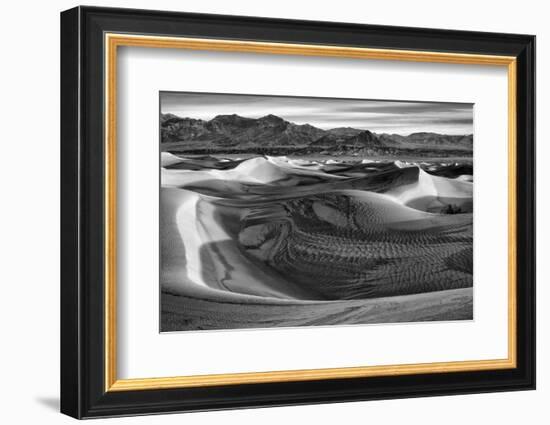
[[240, 193, 472, 299]]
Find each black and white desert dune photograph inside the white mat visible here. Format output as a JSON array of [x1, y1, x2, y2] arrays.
[[160, 92, 474, 332]]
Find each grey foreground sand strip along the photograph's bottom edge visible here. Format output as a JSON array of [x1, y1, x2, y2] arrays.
[[161, 288, 472, 331]]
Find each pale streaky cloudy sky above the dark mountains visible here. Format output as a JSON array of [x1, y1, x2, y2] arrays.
[[160, 92, 473, 135]]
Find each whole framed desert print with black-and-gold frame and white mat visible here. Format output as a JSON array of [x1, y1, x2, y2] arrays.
[[61, 7, 535, 418]]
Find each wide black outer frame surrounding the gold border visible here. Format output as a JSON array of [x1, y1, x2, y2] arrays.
[[61, 6, 535, 418]]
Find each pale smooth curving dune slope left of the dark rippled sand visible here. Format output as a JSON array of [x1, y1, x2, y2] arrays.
[[161, 188, 314, 299]]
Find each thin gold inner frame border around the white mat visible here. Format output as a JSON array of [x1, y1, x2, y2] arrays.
[[104, 33, 517, 391]]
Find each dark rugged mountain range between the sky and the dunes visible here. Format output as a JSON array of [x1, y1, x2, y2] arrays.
[[160, 114, 473, 155]]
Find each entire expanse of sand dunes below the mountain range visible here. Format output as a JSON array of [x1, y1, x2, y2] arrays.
[[161, 153, 473, 331]]
